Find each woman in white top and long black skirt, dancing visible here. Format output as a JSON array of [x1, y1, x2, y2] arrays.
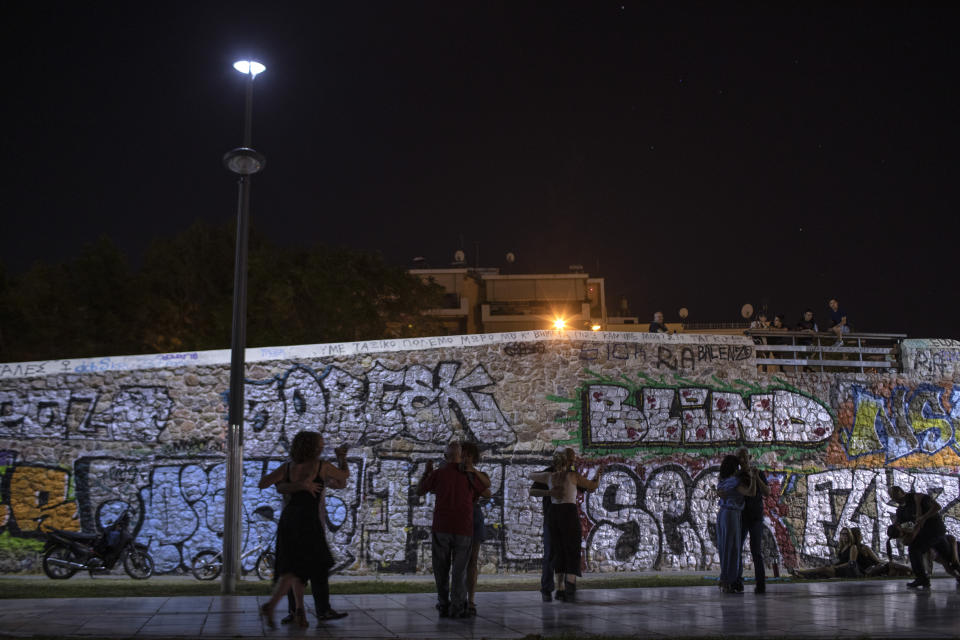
[[530, 449, 601, 602]]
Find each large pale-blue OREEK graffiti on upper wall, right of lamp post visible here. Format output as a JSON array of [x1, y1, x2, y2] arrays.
[[245, 361, 516, 456]]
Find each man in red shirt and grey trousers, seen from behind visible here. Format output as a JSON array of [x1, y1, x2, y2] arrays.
[[417, 442, 484, 618]]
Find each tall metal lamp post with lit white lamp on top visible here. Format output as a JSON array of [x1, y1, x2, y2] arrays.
[[220, 60, 266, 594]]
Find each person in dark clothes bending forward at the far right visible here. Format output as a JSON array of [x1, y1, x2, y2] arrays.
[[889, 487, 953, 589]]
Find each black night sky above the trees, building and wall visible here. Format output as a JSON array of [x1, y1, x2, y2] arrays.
[[0, 0, 960, 338]]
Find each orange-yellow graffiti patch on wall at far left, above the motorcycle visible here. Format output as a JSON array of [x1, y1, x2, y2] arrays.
[[10, 466, 80, 531]]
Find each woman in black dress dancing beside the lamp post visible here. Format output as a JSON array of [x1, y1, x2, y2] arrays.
[[260, 431, 333, 629]]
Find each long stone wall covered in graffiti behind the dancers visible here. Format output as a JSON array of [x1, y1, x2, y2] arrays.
[[0, 332, 960, 573]]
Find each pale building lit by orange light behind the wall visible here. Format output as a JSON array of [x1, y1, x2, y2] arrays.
[[410, 267, 607, 335]]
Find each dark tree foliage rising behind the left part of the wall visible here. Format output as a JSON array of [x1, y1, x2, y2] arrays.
[[0, 223, 442, 362]]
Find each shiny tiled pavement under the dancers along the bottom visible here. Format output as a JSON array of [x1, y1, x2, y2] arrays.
[[0, 578, 960, 640]]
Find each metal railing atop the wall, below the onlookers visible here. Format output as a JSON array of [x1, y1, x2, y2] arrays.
[[744, 329, 907, 373]]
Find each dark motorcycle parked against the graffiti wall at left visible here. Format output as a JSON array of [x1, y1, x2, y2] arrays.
[[43, 509, 153, 580]]
